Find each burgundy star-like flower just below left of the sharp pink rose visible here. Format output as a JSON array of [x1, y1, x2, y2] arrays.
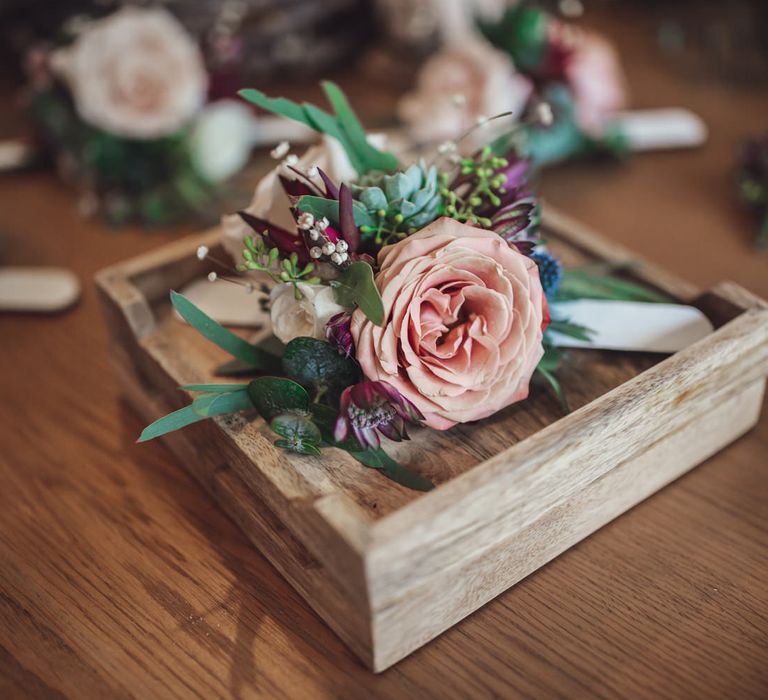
[[334, 381, 424, 448]]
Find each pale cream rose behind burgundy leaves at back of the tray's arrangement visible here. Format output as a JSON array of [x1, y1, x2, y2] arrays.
[[221, 136, 364, 262]]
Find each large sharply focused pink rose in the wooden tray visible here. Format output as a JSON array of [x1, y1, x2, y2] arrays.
[[351, 218, 549, 430]]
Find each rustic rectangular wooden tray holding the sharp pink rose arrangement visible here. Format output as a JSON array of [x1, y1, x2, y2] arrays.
[[97, 210, 768, 671]]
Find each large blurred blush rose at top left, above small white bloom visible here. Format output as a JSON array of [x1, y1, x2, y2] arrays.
[[52, 6, 208, 139]]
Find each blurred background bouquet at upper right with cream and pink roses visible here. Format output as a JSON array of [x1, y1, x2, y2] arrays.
[[399, 2, 627, 164]]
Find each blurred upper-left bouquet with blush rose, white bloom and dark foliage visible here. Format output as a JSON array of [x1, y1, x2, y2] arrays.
[[28, 6, 274, 225]]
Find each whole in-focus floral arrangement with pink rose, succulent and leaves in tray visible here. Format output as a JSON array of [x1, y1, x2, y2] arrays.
[[141, 83, 656, 489]]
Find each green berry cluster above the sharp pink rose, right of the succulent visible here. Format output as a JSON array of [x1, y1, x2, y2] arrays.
[[440, 146, 509, 227]]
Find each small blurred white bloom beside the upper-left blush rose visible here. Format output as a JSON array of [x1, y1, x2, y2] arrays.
[[189, 100, 256, 183]]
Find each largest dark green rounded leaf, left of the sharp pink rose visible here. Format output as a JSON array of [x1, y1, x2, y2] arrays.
[[283, 338, 360, 401]]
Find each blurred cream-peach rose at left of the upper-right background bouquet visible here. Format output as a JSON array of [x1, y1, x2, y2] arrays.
[[398, 37, 533, 143]]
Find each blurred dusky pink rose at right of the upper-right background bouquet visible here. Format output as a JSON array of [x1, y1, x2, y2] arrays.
[[552, 22, 627, 136]]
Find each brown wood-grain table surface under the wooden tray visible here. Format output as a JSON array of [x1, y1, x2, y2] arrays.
[[0, 5, 768, 699]]
